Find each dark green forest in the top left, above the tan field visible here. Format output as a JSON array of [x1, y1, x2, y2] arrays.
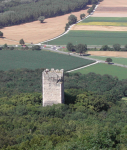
[[0, 0, 98, 27]]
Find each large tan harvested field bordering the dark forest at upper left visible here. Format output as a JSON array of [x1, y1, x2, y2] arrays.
[[0, 6, 89, 45]]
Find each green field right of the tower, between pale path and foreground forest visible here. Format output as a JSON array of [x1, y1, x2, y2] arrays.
[[72, 63, 127, 80]]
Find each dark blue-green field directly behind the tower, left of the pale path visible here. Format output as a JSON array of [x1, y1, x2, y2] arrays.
[[0, 50, 94, 71]]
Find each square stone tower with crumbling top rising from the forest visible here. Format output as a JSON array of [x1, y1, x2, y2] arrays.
[[42, 69, 64, 106]]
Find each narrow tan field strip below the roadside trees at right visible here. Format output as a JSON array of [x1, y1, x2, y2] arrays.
[[88, 51, 127, 58]]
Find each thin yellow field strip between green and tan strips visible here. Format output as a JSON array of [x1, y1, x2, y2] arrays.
[[77, 22, 127, 27]]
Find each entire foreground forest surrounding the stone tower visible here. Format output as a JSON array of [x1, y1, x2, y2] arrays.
[[0, 68, 127, 150]]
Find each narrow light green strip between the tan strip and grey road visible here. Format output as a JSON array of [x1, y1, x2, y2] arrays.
[[88, 56, 127, 65]]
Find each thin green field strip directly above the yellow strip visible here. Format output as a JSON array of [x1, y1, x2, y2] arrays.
[[82, 17, 127, 22]]
